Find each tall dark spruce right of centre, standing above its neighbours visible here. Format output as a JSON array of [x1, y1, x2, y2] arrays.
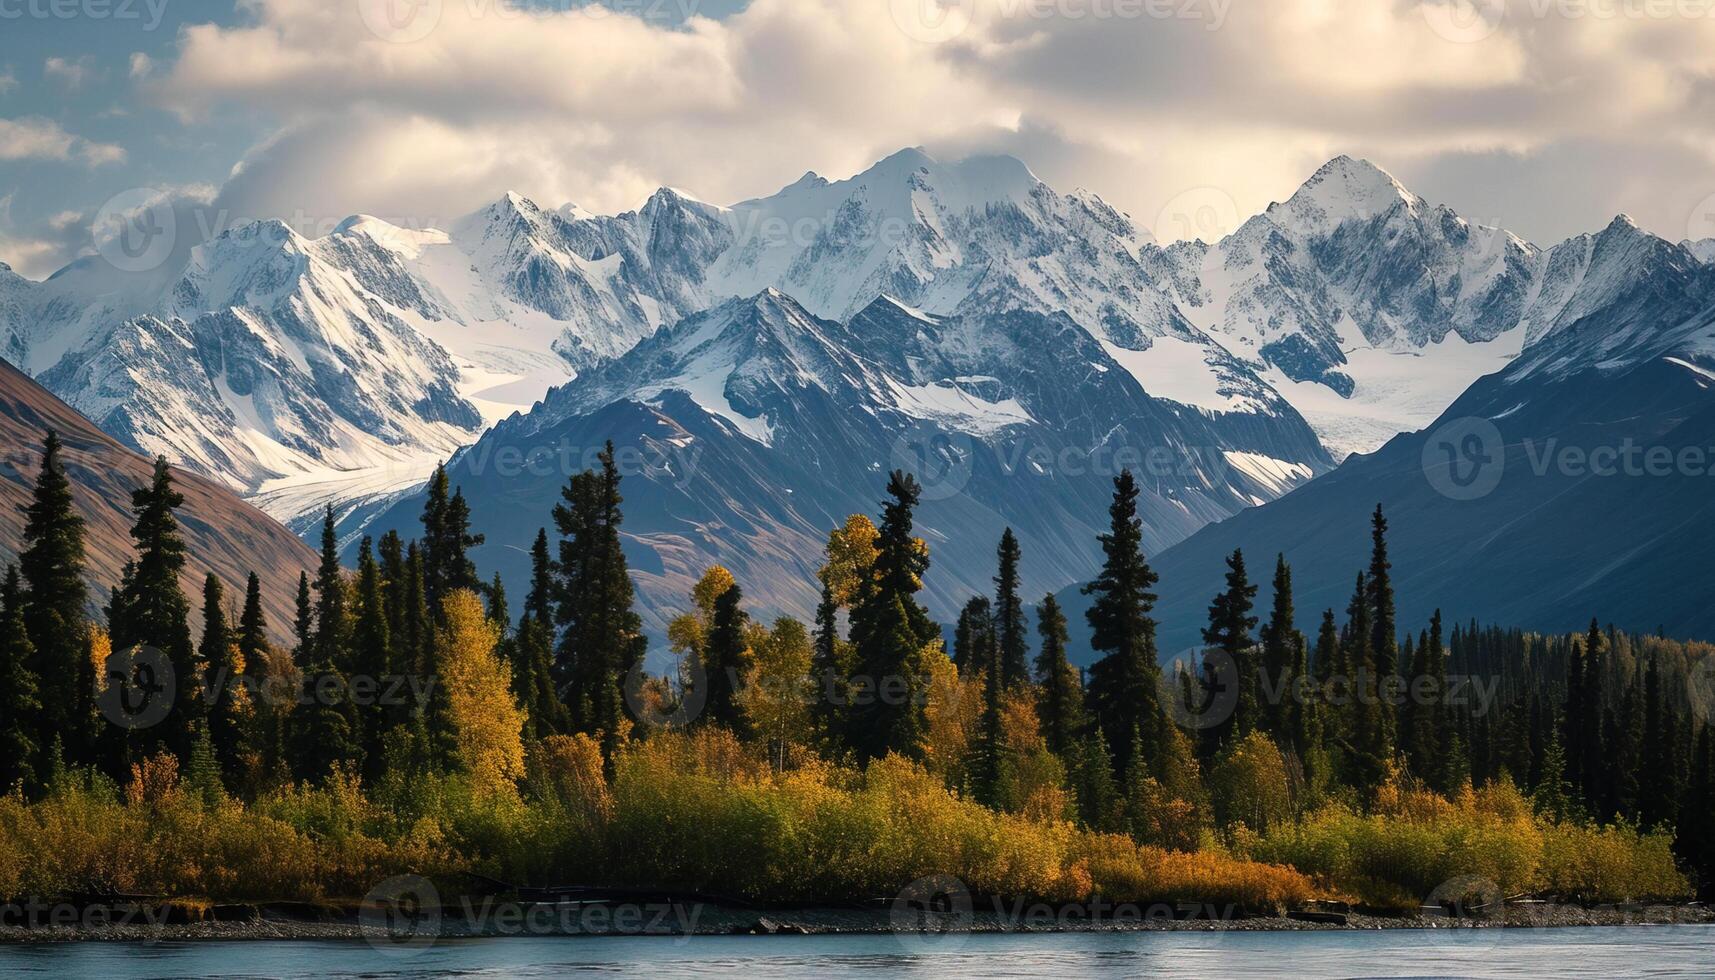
[[1084, 470, 1164, 786]]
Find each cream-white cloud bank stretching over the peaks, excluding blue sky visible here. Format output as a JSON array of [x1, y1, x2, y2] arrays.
[[141, 0, 1715, 239]]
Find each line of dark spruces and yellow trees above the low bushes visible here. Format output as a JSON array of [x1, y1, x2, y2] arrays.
[[0, 433, 1715, 882]]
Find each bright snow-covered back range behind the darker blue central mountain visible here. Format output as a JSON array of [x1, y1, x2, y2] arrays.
[[0, 149, 1708, 580]]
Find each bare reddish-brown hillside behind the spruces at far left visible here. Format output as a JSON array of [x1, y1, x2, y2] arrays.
[[0, 360, 317, 640]]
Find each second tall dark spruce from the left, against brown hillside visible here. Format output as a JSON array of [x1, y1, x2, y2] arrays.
[[111, 457, 204, 759]]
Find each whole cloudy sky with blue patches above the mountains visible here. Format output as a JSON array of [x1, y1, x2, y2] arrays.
[[0, 0, 1715, 276]]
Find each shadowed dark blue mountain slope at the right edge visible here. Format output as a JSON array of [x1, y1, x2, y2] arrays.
[[1131, 218, 1715, 649]]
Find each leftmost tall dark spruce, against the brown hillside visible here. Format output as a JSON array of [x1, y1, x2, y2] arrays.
[[17, 429, 94, 764]]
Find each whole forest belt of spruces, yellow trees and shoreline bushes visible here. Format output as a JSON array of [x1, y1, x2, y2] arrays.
[[0, 433, 1715, 908]]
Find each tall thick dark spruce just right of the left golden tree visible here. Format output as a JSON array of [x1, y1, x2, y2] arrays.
[[554, 443, 647, 748]]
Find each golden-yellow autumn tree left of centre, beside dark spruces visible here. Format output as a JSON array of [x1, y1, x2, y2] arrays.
[[436, 589, 525, 793]]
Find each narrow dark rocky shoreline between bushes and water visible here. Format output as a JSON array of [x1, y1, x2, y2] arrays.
[[0, 899, 1715, 946]]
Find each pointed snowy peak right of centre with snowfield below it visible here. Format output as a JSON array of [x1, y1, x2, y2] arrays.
[[1149, 156, 1540, 457]]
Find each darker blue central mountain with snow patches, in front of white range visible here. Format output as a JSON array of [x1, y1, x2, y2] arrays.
[[358, 287, 1329, 645]]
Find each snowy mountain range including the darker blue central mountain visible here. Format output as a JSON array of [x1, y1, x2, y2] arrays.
[[0, 149, 1715, 648]]
